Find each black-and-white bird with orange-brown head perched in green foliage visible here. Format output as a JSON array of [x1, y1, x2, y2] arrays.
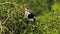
[[24, 3, 36, 21]]
